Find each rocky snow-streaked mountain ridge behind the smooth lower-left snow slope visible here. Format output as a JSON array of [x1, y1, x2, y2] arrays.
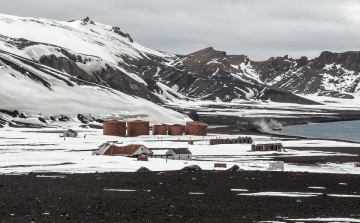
[[0, 14, 360, 125]]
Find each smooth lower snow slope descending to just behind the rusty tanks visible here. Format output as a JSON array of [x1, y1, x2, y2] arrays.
[[0, 42, 188, 123]]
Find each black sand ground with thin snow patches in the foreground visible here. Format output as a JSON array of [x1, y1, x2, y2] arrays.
[[0, 171, 360, 223]]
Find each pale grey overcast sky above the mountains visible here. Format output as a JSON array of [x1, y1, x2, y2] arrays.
[[0, 0, 360, 60]]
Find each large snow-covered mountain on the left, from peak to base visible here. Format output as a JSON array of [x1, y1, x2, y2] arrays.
[[0, 15, 188, 123]]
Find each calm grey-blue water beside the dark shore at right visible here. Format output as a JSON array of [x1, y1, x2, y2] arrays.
[[270, 121, 360, 142]]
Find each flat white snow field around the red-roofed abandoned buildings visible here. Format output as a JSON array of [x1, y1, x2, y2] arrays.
[[0, 125, 359, 174]]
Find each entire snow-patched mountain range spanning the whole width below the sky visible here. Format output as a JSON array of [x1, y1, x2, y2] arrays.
[[0, 14, 360, 125]]
